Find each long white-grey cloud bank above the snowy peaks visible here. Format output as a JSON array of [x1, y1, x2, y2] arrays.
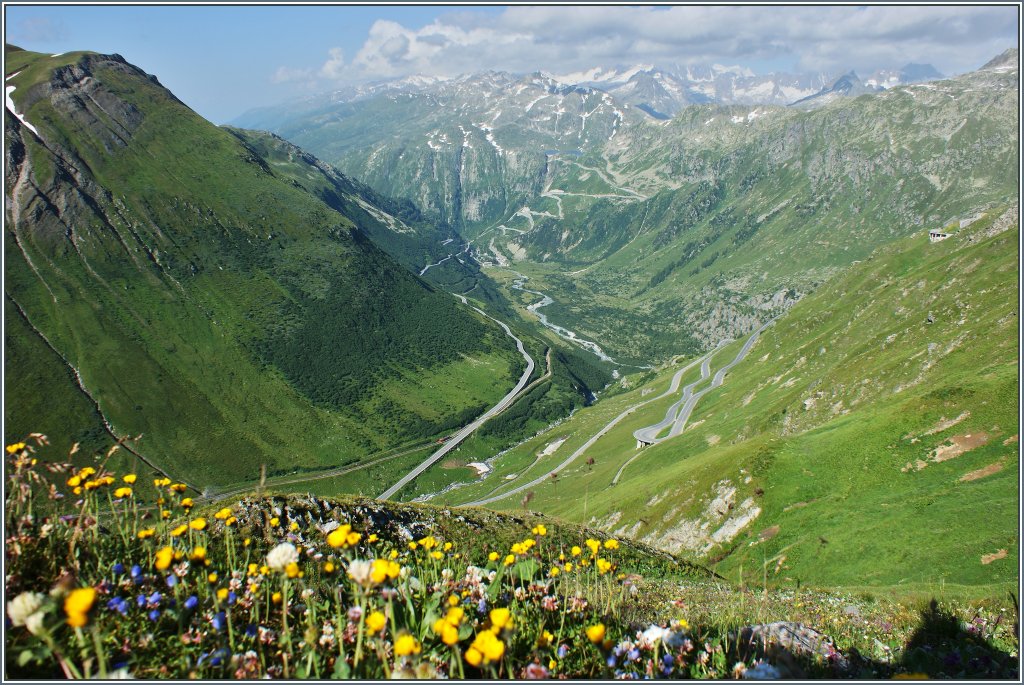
[[319, 6, 1018, 81]]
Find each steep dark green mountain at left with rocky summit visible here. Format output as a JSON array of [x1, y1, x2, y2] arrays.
[[4, 46, 522, 486]]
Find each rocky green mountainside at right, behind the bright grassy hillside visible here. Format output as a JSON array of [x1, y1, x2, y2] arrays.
[[481, 54, 1019, 359]]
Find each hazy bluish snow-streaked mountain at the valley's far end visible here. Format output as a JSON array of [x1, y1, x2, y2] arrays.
[[239, 72, 644, 231]]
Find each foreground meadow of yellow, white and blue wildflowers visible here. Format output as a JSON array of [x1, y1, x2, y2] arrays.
[[5, 435, 1017, 679]]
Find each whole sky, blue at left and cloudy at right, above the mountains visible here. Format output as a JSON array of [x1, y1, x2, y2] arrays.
[[4, 3, 1020, 124]]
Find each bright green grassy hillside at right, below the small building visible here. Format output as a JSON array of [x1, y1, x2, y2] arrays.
[[463, 213, 1019, 586]]
